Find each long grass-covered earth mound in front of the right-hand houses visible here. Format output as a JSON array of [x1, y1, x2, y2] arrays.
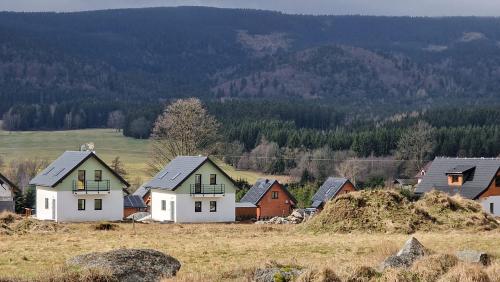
[[304, 190, 499, 234]]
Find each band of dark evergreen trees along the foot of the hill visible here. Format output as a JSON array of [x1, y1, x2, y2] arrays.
[[3, 100, 500, 157]]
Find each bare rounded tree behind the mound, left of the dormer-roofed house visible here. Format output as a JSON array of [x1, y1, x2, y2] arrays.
[[396, 121, 435, 174]]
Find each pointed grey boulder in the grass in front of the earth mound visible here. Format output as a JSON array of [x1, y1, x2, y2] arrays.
[[379, 237, 426, 271]]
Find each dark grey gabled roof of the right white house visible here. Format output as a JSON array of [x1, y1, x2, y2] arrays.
[[143, 156, 233, 190]]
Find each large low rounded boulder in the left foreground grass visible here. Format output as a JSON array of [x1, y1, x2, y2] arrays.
[[67, 249, 181, 282]]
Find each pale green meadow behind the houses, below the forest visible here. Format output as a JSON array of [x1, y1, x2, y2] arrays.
[[0, 129, 288, 183]]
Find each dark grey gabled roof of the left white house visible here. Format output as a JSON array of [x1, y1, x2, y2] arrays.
[[30, 151, 129, 187]]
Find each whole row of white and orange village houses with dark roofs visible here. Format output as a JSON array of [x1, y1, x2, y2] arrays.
[[0, 148, 500, 223]]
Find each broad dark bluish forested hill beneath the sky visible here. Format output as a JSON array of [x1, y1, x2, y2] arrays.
[[0, 7, 500, 121]]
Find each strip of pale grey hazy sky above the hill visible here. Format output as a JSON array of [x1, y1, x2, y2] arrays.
[[0, 0, 500, 16]]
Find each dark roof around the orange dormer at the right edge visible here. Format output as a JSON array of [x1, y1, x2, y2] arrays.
[[416, 158, 500, 199]]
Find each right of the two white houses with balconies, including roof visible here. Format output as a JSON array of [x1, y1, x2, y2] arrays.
[[143, 156, 236, 222]]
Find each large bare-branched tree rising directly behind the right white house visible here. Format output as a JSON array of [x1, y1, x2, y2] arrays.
[[148, 98, 219, 175]]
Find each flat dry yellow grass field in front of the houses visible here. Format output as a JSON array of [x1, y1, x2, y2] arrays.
[[0, 223, 500, 281]]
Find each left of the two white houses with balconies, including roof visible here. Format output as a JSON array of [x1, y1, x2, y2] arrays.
[[30, 151, 129, 222]]
